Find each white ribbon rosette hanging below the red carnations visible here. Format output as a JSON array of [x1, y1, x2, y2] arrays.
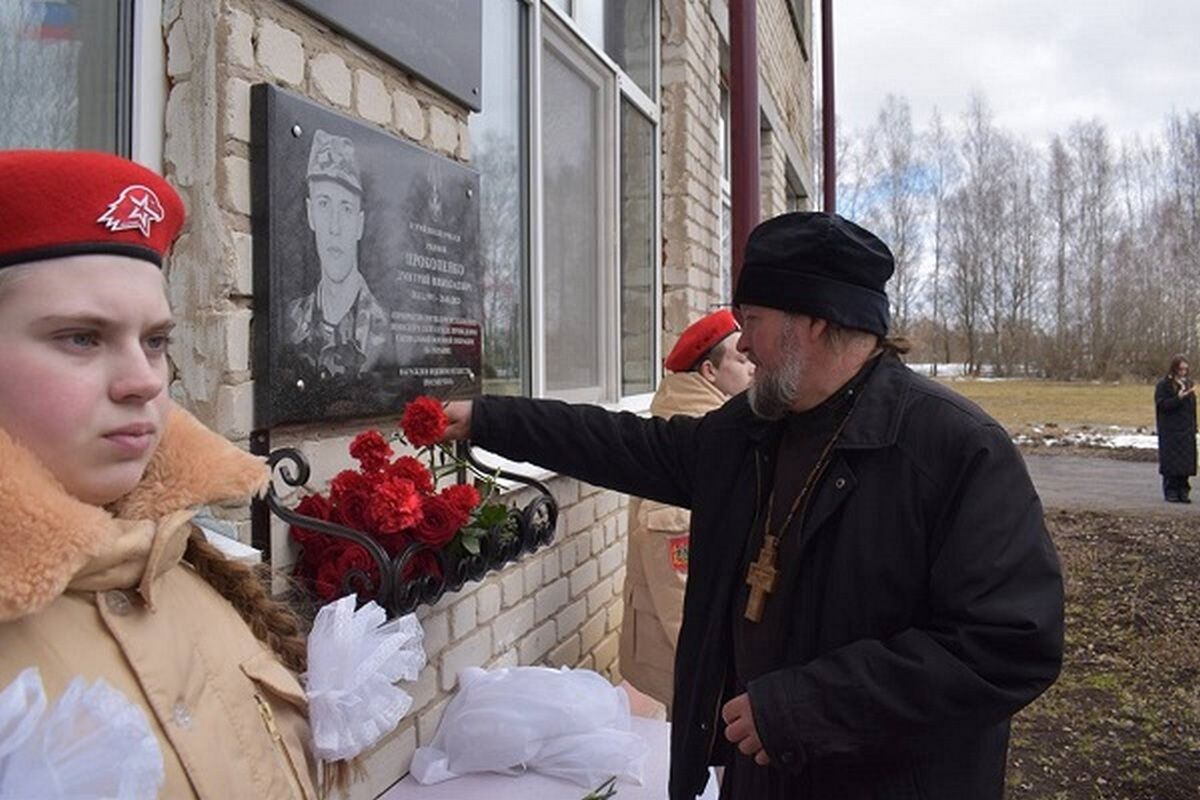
[[307, 595, 425, 762]]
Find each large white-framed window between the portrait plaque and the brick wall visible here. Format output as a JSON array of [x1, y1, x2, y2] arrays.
[[470, 0, 660, 403]]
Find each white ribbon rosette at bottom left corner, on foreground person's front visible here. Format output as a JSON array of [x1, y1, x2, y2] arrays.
[[0, 667, 164, 800]]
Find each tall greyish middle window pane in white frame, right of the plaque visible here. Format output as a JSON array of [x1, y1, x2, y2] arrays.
[[541, 40, 602, 399]]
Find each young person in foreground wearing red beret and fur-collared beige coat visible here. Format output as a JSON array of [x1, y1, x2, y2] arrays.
[[0, 151, 317, 800]]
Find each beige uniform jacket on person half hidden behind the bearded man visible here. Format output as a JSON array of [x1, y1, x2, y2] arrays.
[[620, 372, 728, 711]]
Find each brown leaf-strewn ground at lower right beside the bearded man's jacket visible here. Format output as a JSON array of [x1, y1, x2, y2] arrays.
[[1008, 511, 1200, 800]]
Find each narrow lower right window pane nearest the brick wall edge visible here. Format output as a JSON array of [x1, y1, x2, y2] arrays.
[[620, 101, 656, 395]]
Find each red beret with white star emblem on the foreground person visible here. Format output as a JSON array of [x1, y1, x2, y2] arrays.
[[0, 150, 184, 267]]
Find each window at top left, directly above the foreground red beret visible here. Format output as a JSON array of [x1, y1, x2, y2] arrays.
[[0, 0, 133, 156]]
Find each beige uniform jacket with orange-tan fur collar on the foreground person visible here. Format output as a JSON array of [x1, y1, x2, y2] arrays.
[[0, 409, 316, 800]]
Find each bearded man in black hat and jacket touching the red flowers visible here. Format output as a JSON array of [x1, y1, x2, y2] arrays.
[[448, 212, 1063, 800]]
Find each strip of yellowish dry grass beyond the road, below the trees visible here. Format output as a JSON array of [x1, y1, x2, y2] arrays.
[[942, 379, 1154, 433]]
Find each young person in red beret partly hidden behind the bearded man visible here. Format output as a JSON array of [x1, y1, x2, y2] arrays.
[[620, 308, 754, 716]]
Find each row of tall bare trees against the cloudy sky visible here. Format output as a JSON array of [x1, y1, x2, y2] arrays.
[[845, 95, 1200, 379]]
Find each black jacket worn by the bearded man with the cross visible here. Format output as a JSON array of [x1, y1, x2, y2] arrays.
[[472, 356, 1063, 800]]
